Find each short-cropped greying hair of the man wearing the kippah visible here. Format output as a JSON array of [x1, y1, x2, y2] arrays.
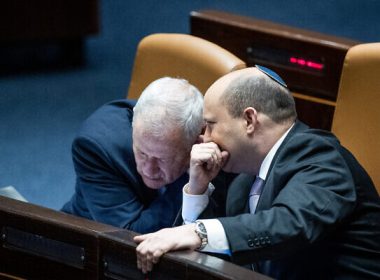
[[221, 73, 297, 123]]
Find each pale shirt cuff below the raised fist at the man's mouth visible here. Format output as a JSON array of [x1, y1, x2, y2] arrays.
[[182, 183, 215, 224]]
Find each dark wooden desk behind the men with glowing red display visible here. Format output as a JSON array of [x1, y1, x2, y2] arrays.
[[190, 10, 359, 130]]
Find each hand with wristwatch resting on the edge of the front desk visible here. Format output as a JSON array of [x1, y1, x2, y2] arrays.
[[133, 224, 201, 273]]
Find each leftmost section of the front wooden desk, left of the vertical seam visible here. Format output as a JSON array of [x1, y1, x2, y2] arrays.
[[0, 196, 114, 279]]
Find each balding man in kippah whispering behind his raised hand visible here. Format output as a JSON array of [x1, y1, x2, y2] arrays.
[[135, 66, 380, 279]]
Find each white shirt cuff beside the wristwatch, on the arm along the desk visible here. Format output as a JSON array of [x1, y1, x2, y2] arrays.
[[199, 219, 231, 255]]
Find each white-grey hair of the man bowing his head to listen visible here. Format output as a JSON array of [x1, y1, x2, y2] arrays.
[[132, 77, 203, 145]]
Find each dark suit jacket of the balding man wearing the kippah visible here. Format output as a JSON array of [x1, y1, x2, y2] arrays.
[[220, 122, 380, 279]]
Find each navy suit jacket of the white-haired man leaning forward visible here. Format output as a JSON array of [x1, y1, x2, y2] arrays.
[[62, 100, 233, 233]]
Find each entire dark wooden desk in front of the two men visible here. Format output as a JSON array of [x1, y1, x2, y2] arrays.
[[0, 196, 270, 280]]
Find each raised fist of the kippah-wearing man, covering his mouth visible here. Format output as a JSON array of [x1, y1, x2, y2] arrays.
[[188, 142, 228, 194]]
